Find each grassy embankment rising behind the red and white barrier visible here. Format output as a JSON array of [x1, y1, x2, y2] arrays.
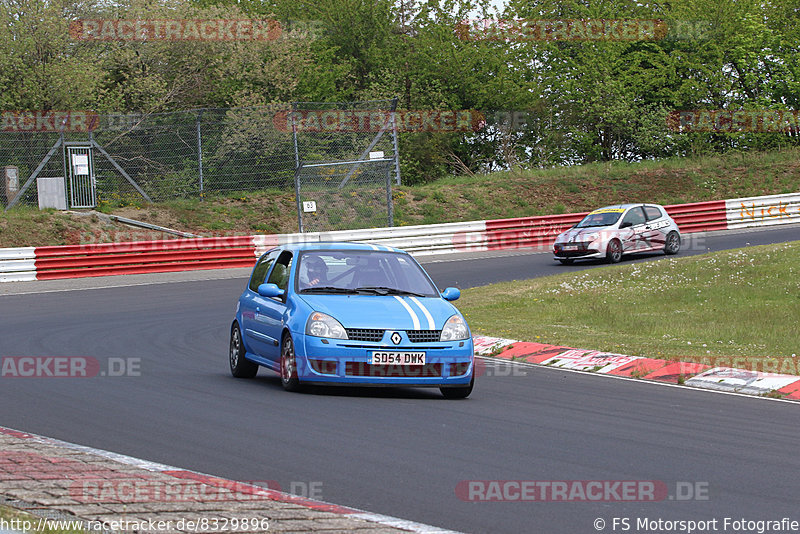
[[0, 149, 800, 247]]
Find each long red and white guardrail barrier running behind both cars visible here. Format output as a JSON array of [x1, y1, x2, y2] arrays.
[[0, 193, 800, 282]]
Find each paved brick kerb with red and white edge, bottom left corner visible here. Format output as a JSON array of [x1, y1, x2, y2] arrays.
[[0, 427, 462, 534]]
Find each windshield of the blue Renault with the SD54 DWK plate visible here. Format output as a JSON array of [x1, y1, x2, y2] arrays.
[[296, 250, 439, 297]]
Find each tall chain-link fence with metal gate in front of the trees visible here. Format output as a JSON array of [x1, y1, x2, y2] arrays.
[[0, 101, 399, 231]]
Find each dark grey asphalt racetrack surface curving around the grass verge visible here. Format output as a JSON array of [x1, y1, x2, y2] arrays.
[[0, 227, 800, 533]]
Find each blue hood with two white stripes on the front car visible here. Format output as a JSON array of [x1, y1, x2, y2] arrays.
[[298, 294, 457, 330]]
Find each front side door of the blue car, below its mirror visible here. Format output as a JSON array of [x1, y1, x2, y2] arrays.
[[252, 250, 292, 362]]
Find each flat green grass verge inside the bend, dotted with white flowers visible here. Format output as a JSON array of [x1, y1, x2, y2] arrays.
[[458, 241, 800, 373]]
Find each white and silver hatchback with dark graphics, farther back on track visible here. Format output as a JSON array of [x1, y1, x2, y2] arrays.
[[553, 204, 681, 264]]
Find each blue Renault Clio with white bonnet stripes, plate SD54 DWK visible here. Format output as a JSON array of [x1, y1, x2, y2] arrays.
[[230, 243, 474, 399]]
